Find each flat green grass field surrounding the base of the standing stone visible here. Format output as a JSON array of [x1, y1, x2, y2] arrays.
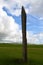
[[0, 44, 43, 65]]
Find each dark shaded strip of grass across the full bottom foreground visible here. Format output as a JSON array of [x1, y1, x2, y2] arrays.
[[0, 58, 43, 65]]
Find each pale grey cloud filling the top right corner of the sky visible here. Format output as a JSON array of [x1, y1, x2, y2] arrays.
[[31, 0, 43, 16]]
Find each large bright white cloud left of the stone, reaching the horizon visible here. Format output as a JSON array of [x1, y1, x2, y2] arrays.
[[0, 2, 21, 42]]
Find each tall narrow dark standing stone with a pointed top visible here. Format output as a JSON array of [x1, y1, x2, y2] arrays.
[[21, 6, 27, 62]]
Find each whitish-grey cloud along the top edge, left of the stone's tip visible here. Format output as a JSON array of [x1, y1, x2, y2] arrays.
[[1, 0, 29, 16]]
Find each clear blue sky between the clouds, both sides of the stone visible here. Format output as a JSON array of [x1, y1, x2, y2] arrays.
[[3, 7, 43, 33]]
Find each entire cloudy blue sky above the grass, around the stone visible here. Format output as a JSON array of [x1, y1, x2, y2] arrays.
[[0, 0, 43, 44]]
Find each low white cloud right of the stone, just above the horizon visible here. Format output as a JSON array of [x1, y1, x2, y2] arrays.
[[27, 31, 43, 44]]
